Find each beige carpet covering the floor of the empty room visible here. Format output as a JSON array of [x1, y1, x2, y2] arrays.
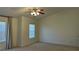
[[6, 43, 79, 51]]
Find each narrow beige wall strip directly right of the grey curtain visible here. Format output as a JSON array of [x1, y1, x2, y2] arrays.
[[12, 18, 18, 47]]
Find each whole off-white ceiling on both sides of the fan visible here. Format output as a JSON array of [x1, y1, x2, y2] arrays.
[[0, 7, 78, 19]]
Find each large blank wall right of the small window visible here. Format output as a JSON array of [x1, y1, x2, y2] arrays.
[[39, 9, 79, 47]]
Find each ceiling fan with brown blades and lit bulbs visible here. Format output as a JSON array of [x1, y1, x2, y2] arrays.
[[25, 8, 45, 16]]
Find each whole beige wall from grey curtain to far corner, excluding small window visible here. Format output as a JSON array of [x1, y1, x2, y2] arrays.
[[12, 16, 39, 47]]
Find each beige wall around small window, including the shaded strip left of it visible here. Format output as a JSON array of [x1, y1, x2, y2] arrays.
[[18, 16, 38, 47]]
